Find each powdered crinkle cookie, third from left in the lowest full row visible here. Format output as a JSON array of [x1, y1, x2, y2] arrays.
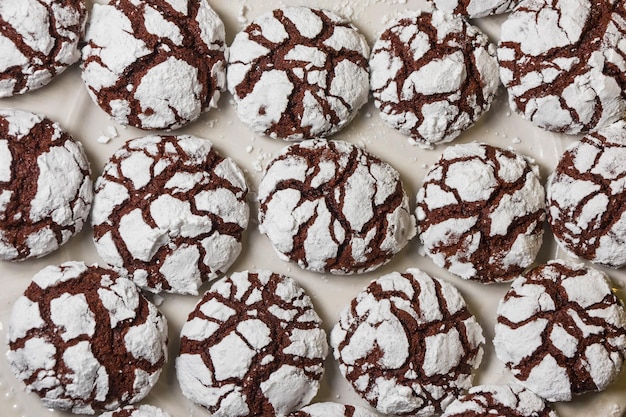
[[330, 269, 484, 417]]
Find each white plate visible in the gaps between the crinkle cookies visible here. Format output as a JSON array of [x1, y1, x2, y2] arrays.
[[0, 0, 626, 417]]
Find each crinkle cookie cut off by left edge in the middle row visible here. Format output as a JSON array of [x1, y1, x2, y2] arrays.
[[0, 109, 93, 261]]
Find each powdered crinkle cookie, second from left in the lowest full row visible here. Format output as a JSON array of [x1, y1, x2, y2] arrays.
[[176, 271, 328, 417]]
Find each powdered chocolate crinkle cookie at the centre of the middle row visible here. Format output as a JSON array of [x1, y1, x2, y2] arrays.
[[258, 139, 415, 274]]
